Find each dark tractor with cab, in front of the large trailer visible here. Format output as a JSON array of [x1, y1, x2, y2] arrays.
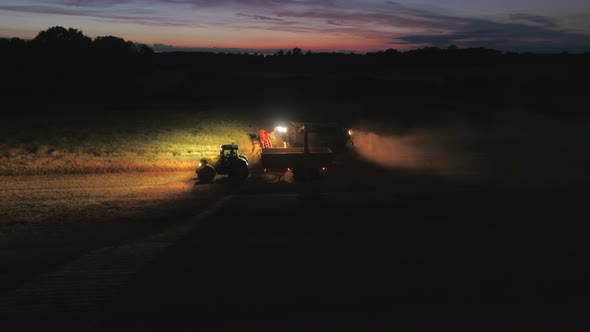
[[196, 143, 250, 183]]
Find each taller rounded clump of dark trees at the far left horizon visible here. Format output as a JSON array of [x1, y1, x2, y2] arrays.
[[0, 26, 154, 102]]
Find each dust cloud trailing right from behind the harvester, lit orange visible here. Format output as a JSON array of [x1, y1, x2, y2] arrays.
[[353, 110, 590, 185]]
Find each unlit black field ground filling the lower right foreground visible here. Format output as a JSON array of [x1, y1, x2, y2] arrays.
[[3, 151, 590, 331]]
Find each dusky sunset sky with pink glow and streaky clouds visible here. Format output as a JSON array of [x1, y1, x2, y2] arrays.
[[0, 0, 590, 52]]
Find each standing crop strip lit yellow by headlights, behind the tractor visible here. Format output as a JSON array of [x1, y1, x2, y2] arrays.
[[0, 109, 260, 175]]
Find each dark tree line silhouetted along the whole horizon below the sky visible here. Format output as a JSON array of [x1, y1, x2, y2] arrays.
[[0, 26, 590, 73]]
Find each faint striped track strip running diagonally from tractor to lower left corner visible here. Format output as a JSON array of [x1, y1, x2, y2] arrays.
[[0, 195, 233, 319]]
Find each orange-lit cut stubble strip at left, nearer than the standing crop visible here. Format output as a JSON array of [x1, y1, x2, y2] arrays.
[[0, 172, 198, 233]]
